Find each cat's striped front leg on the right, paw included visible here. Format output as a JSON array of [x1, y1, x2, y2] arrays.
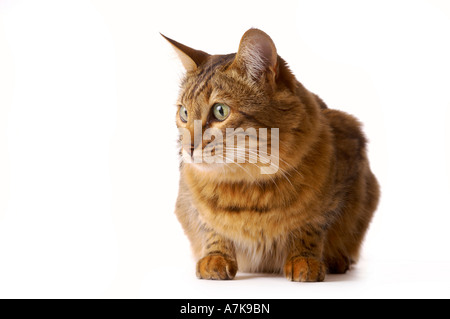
[[284, 224, 326, 282]]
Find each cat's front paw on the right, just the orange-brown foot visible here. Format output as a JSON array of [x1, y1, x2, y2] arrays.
[[284, 257, 325, 282]]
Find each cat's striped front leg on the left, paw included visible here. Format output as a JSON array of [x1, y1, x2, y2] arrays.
[[197, 230, 238, 279]]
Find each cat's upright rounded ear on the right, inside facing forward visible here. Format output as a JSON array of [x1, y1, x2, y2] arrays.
[[233, 29, 278, 81]]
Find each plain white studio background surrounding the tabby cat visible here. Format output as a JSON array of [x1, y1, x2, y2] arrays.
[[0, 0, 450, 298]]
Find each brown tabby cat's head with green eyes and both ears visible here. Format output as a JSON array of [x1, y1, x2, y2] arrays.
[[164, 29, 319, 184]]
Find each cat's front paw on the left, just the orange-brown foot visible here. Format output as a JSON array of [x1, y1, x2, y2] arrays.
[[197, 255, 238, 280]]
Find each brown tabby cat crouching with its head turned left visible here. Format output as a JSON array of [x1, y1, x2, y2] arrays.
[[165, 29, 379, 282]]
